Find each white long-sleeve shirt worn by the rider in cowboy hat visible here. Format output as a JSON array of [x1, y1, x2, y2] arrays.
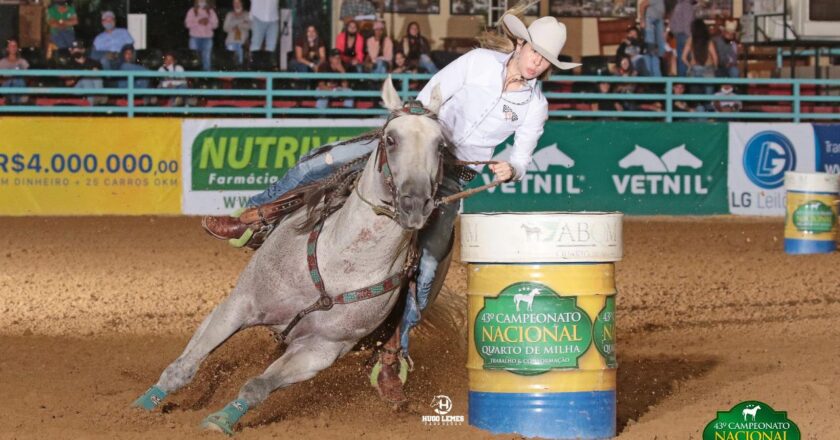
[[417, 49, 548, 180]]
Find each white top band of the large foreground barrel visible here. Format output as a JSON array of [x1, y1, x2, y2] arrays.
[[461, 212, 624, 263]]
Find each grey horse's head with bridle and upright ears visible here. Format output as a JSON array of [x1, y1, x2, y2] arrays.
[[376, 77, 445, 229]]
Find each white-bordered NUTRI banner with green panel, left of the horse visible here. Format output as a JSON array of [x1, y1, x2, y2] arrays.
[[182, 119, 382, 215]]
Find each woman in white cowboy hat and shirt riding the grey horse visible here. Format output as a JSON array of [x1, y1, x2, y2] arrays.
[[205, 6, 579, 403]]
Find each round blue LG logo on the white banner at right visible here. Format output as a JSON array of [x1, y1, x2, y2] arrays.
[[744, 131, 796, 189]]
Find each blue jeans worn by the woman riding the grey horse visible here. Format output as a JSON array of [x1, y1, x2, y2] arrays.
[[248, 139, 465, 353]]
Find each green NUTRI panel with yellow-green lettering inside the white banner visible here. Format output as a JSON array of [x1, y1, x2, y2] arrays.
[[191, 127, 370, 191]]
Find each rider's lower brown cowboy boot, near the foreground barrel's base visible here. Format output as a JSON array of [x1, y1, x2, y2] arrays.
[[370, 327, 408, 410]]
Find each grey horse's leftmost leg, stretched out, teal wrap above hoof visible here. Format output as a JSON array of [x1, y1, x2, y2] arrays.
[[134, 293, 253, 410]]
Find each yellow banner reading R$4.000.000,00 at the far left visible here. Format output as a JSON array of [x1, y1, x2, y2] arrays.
[[0, 117, 181, 215]]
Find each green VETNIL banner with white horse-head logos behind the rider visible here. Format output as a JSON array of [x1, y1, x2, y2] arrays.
[[464, 122, 728, 215]]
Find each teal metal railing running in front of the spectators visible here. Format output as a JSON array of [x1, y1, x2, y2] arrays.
[[0, 70, 840, 122]]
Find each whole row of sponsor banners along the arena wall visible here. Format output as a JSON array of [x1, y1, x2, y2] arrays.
[[0, 117, 840, 216]]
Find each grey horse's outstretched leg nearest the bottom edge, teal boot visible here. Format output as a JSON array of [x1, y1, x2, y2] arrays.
[[202, 338, 346, 435]]
